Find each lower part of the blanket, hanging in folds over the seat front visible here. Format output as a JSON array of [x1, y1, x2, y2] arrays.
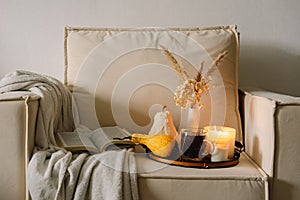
[[27, 150, 138, 200]]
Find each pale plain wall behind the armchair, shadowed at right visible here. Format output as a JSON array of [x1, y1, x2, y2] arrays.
[[0, 0, 300, 96]]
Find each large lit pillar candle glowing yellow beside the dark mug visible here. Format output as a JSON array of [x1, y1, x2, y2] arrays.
[[204, 126, 235, 159]]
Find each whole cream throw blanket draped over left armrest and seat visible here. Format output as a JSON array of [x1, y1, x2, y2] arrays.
[[0, 71, 138, 200]]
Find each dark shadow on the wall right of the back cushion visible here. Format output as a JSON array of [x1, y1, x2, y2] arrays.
[[239, 44, 300, 96]]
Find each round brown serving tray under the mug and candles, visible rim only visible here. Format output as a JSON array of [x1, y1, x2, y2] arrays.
[[147, 152, 239, 169]]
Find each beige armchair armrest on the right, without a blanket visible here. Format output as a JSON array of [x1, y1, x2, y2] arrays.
[[240, 89, 300, 199]]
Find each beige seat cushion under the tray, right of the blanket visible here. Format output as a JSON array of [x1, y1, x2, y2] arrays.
[[136, 153, 268, 200]]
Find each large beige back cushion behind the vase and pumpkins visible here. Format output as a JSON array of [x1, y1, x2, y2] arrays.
[[65, 26, 242, 140]]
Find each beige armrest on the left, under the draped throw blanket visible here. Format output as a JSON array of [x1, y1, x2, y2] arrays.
[[0, 92, 38, 199]]
